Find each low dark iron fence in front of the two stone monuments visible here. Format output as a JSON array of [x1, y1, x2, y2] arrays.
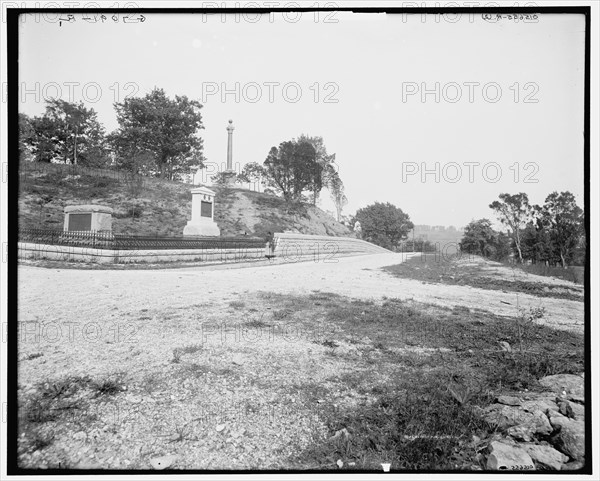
[[19, 229, 265, 250]]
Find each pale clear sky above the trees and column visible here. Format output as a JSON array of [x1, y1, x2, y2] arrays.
[[19, 12, 585, 227]]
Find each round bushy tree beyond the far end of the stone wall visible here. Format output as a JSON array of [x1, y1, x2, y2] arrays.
[[355, 202, 414, 249]]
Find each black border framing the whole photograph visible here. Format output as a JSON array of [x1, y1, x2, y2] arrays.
[[6, 6, 593, 476]]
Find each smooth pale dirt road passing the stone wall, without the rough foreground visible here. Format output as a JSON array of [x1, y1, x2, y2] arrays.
[[19, 249, 584, 331]]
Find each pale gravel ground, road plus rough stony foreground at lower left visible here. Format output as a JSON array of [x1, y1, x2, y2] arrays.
[[18, 254, 584, 469]]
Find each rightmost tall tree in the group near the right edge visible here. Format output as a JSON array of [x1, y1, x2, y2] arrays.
[[542, 191, 584, 269]]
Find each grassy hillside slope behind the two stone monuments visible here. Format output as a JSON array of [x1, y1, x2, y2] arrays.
[[19, 165, 353, 237]]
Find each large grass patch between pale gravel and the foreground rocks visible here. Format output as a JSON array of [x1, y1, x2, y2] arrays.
[[255, 294, 583, 471]]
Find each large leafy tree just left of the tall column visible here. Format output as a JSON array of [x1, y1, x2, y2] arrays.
[[111, 88, 204, 180]]
